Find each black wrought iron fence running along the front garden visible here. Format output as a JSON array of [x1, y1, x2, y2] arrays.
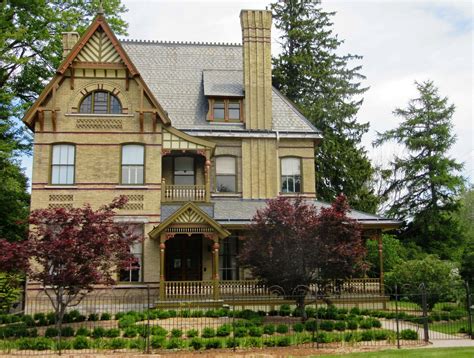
[[0, 286, 473, 356]]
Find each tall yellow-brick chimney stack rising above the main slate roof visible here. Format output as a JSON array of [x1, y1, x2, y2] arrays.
[[240, 10, 272, 130]]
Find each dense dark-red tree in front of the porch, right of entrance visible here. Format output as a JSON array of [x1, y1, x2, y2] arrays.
[[239, 195, 365, 314]]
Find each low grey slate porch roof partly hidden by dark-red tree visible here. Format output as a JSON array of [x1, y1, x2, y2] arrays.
[[161, 198, 401, 226]]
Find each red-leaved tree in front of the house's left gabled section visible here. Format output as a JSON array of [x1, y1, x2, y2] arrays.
[[0, 197, 139, 325]]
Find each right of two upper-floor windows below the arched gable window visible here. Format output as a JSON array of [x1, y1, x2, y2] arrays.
[[122, 144, 145, 184]]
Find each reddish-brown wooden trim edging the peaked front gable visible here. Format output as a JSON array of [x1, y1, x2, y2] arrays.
[[23, 14, 171, 130]]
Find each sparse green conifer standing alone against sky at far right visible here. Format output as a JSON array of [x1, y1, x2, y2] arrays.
[[374, 81, 464, 258]]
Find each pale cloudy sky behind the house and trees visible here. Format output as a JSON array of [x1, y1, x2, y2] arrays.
[[20, 0, 474, 183]]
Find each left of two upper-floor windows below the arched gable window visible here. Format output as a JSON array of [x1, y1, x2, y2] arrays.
[[51, 144, 75, 185]]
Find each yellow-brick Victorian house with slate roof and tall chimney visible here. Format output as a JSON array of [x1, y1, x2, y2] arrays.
[[23, 10, 397, 298]]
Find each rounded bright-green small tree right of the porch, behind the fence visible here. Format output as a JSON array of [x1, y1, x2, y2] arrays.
[[385, 255, 463, 308]]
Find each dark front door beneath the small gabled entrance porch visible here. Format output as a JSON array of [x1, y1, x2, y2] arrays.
[[165, 235, 202, 281]]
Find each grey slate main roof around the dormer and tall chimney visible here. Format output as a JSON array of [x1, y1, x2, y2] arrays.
[[121, 40, 321, 138]]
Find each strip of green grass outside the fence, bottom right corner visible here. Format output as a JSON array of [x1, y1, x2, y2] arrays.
[[314, 347, 474, 358]]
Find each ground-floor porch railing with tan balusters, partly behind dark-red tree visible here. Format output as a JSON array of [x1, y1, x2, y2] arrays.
[[160, 278, 381, 300]]
